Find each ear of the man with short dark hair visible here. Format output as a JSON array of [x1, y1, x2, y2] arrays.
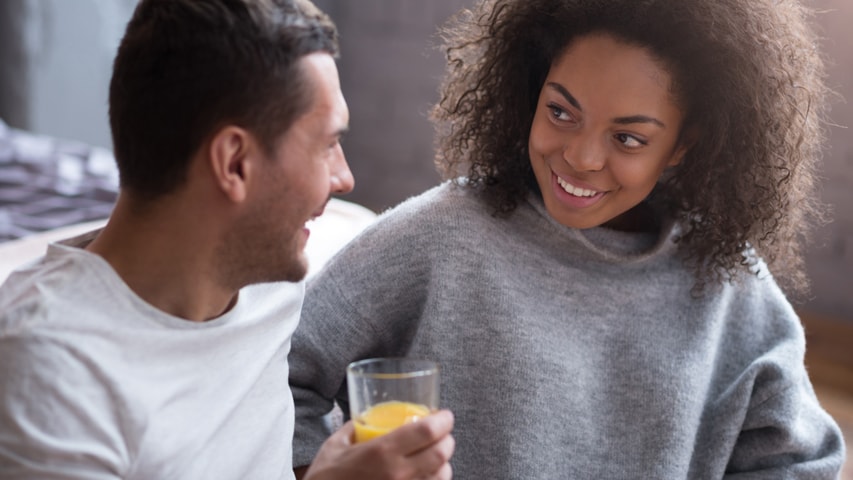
[[208, 125, 254, 202]]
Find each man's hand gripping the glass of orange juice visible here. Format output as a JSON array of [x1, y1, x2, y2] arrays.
[[304, 410, 456, 480]]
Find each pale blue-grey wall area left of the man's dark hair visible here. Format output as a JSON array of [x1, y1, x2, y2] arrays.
[[0, 0, 136, 148]]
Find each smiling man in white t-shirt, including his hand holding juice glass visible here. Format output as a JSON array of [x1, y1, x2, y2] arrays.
[[0, 0, 454, 479]]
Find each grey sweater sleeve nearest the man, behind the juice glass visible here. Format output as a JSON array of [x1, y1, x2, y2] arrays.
[[288, 208, 428, 467]]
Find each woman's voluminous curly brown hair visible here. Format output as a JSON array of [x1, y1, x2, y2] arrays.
[[432, 0, 829, 293]]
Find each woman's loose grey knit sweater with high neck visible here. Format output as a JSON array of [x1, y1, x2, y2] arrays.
[[290, 183, 844, 480]]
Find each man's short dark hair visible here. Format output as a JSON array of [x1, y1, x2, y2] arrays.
[[109, 0, 338, 198]]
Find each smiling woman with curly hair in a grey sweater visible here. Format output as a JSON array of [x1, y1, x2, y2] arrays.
[[290, 0, 844, 479]]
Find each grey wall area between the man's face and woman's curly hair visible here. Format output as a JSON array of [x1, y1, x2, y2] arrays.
[[316, 0, 473, 211]]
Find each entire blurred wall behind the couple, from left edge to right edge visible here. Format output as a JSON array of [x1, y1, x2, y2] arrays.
[[0, 0, 853, 322]]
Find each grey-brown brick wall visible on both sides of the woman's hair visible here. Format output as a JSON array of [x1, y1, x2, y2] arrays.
[[316, 0, 853, 321]]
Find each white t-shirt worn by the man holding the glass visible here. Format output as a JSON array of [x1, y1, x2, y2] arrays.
[[0, 232, 304, 480]]
